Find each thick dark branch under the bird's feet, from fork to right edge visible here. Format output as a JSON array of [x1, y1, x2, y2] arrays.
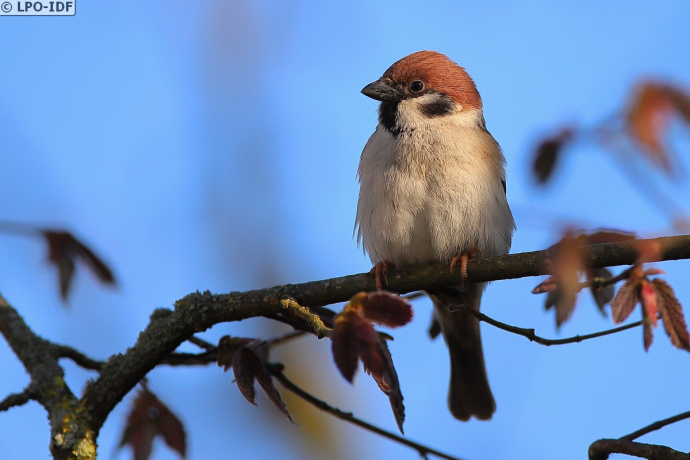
[[78, 236, 690, 432]]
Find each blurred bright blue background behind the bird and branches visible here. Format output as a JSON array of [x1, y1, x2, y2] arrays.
[[0, 0, 690, 459]]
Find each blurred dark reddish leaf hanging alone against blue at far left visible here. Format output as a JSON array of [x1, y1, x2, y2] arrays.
[[43, 230, 115, 300]]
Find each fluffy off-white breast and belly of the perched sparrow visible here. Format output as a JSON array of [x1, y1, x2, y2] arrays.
[[355, 110, 515, 266]]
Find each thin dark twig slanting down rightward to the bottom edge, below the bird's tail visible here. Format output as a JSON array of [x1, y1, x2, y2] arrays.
[[269, 366, 461, 460]]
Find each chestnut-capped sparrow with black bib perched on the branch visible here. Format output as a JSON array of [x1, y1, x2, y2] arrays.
[[355, 51, 515, 421]]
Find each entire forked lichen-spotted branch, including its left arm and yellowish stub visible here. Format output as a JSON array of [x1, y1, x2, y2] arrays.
[[0, 235, 690, 458]]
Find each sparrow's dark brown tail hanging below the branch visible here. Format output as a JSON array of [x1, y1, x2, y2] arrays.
[[428, 283, 496, 421]]
